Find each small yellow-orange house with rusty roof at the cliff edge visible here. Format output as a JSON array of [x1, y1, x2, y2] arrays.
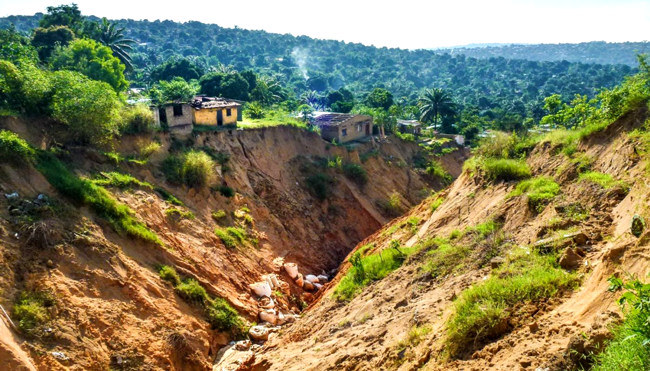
[[192, 96, 241, 126]]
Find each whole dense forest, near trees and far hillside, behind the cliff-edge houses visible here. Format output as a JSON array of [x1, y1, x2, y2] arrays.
[[0, 5, 636, 138]]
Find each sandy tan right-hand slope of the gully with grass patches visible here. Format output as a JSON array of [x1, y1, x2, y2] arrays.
[[252, 108, 650, 371]]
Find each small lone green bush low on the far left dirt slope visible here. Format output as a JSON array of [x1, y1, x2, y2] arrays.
[[13, 291, 54, 335]]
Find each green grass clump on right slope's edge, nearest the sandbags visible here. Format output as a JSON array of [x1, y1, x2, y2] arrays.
[[333, 244, 415, 301]]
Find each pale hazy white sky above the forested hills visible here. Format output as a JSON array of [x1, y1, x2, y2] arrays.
[[0, 0, 650, 49]]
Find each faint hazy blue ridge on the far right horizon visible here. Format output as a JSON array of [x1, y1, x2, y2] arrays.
[[435, 41, 650, 66]]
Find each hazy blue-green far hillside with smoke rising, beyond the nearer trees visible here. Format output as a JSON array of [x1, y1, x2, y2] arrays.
[[0, 13, 634, 108]]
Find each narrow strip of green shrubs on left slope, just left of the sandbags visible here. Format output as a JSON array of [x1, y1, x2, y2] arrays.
[[158, 265, 246, 335]]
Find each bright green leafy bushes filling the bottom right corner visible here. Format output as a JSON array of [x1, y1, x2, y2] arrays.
[[591, 277, 650, 371]]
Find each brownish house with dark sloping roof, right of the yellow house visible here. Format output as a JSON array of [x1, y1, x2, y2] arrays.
[[314, 113, 372, 143]]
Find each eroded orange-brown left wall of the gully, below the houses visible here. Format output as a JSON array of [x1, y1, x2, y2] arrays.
[[0, 118, 467, 370]]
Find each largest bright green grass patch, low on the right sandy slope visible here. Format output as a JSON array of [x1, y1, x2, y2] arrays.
[[446, 248, 578, 356]]
